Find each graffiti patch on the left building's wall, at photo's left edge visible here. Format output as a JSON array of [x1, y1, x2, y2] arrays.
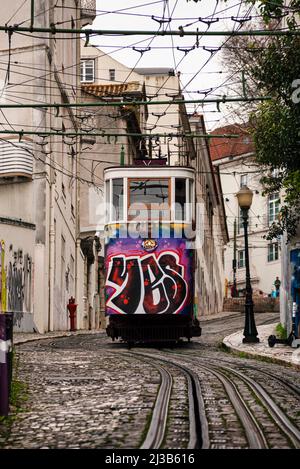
[[0, 241, 32, 312]]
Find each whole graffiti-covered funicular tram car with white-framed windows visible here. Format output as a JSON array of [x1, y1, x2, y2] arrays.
[[104, 166, 201, 343]]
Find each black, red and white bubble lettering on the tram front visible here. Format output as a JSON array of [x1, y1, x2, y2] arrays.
[[107, 252, 188, 314]]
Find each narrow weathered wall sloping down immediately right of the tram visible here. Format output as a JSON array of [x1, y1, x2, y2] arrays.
[[184, 115, 229, 319]]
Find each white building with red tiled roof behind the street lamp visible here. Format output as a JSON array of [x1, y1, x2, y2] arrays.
[[210, 125, 281, 296]]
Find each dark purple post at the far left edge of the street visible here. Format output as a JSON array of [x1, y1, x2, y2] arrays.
[[0, 313, 13, 416]]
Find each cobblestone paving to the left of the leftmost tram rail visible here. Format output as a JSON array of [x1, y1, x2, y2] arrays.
[[0, 336, 160, 449]]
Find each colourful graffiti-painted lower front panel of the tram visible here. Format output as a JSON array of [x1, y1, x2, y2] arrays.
[[106, 239, 192, 314]]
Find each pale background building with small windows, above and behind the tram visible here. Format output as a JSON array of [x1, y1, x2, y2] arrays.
[[81, 41, 182, 164]]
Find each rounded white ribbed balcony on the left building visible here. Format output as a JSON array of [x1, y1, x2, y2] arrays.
[[0, 139, 33, 179]]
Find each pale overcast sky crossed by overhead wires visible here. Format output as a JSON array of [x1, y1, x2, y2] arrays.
[[90, 0, 253, 130]]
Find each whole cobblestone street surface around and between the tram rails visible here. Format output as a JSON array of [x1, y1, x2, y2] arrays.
[[0, 313, 300, 449]]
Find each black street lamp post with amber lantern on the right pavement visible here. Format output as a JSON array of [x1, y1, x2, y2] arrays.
[[236, 186, 259, 343]]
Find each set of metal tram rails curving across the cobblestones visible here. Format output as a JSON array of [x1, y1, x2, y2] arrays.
[[42, 340, 300, 449]]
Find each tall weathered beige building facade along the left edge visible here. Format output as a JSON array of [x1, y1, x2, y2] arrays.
[[0, 0, 95, 333]]
